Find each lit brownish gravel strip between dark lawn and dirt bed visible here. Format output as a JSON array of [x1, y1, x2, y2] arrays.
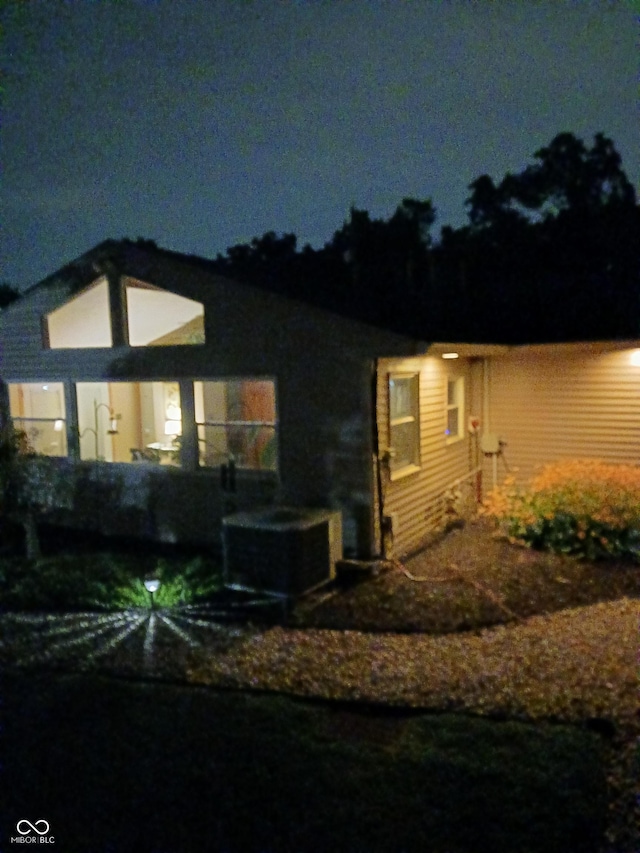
[[188, 599, 640, 728]]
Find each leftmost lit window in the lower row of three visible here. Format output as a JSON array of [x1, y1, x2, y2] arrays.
[[9, 382, 67, 456]]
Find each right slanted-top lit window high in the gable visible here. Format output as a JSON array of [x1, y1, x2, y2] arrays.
[[125, 278, 204, 347]]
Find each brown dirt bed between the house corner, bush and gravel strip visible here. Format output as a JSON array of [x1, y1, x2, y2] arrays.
[[291, 520, 640, 634]]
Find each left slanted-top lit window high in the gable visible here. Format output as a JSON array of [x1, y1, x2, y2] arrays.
[[46, 278, 112, 349]]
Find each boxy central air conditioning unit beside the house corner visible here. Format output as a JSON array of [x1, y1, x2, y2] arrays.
[[222, 507, 342, 597]]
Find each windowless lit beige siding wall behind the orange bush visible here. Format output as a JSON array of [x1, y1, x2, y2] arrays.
[[485, 347, 640, 486]]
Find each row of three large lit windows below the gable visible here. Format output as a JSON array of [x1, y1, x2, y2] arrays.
[[9, 379, 278, 471]]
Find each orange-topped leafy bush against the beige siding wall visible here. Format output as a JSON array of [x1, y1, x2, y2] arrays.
[[483, 459, 640, 562]]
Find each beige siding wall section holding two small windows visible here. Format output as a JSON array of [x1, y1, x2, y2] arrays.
[[378, 356, 482, 557]]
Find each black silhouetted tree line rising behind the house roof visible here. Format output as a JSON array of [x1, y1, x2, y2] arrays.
[[216, 133, 640, 343]]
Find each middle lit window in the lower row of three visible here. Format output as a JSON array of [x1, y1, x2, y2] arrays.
[[76, 382, 182, 465]]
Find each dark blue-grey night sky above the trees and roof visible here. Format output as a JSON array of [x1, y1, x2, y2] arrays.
[[0, 0, 640, 288]]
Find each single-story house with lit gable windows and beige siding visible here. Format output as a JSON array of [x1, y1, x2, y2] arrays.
[[0, 240, 640, 558]]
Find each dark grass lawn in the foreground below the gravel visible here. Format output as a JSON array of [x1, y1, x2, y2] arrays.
[[0, 673, 607, 853]]
